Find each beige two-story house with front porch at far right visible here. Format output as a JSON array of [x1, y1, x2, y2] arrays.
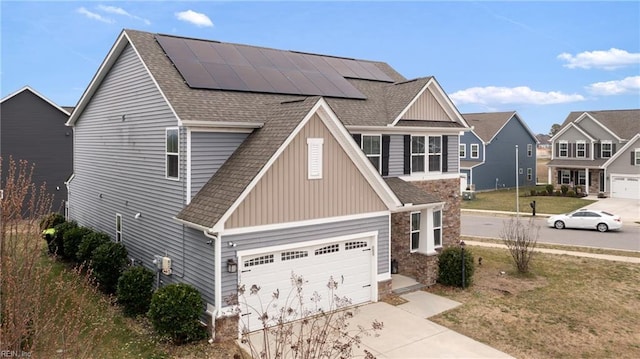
[[548, 109, 640, 199]]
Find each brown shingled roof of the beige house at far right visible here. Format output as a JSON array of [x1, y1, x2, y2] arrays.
[[561, 109, 640, 139]]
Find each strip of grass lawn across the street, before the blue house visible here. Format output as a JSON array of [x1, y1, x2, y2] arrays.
[[461, 187, 595, 214]]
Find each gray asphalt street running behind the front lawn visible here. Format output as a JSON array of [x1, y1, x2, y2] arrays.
[[461, 213, 640, 251]]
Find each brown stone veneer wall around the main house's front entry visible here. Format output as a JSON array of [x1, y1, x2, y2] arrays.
[[391, 178, 460, 285]]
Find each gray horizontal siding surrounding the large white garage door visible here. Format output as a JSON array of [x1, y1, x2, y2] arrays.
[[220, 214, 390, 298]]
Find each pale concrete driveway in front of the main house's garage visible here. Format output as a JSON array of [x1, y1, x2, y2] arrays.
[[351, 291, 512, 359]]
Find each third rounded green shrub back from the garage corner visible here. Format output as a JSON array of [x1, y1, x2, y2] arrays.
[[91, 241, 128, 294]]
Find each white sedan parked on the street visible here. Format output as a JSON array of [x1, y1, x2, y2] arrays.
[[547, 209, 622, 232]]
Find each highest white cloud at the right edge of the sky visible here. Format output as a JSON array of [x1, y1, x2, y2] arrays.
[[558, 48, 640, 70]]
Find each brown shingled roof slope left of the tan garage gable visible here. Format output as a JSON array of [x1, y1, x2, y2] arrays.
[[176, 97, 320, 228]]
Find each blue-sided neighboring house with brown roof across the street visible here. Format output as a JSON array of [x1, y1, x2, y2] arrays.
[[460, 111, 538, 191]]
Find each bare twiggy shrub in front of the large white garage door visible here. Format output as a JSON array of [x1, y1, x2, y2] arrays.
[[235, 273, 383, 359]]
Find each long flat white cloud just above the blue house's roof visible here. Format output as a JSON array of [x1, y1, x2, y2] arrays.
[[450, 86, 585, 105]]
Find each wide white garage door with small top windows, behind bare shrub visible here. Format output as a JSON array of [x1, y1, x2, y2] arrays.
[[239, 237, 377, 331]]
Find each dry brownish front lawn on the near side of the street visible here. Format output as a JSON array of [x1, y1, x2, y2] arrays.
[[427, 246, 640, 358]]
